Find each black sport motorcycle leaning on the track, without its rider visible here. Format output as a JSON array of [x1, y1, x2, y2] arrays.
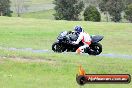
[[52, 32, 104, 55]]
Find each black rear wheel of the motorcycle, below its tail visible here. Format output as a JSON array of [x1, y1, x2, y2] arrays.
[[88, 43, 102, 55]]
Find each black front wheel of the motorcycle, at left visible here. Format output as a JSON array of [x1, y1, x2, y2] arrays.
[[52, 42, 66, 53]]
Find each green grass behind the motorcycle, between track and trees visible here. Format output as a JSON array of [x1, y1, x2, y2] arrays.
[[0, 17, 132, 54]]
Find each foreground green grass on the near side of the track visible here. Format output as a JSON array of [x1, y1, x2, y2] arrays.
[[0, 52, 132, 88]]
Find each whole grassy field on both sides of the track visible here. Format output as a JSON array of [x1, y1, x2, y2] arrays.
[[0, 17, 132, 88]]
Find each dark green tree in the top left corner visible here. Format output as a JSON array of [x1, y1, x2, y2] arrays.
[[0, 0, 12, 16]]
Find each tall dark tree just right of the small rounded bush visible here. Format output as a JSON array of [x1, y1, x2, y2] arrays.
[[99, 0, 124, 22]]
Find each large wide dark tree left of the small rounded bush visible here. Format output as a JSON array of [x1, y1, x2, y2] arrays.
[[54, 0, 84, 20]]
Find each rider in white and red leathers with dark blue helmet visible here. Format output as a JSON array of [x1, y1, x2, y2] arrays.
[[72, 26, 91, 54]]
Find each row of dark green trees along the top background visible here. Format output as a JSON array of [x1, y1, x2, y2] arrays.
[[0, 0, 132, 22]]
